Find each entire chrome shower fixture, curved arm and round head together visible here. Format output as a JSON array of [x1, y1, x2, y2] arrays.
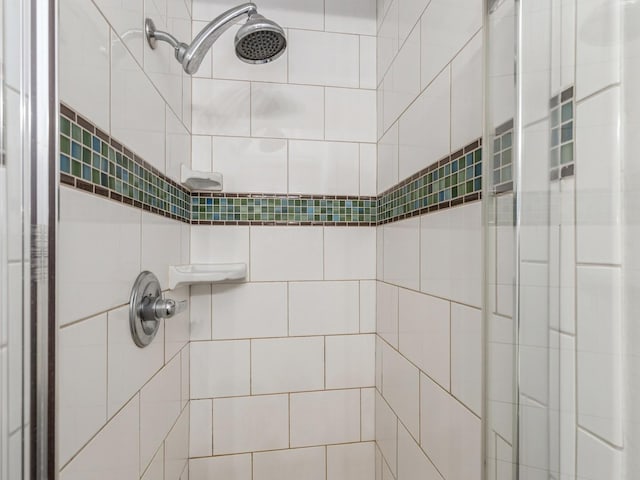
[[145, 3, 287, 75]]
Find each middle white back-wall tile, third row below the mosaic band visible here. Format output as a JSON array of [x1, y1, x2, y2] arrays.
[[251, 337, 325, 395]]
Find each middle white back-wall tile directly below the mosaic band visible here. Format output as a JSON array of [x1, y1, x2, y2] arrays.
[[251, 227, 323, 281]]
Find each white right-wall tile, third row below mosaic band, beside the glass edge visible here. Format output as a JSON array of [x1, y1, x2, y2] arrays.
[[420, 375, 482, 480]]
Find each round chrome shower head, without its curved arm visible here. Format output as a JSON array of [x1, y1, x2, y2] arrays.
[[234, 13, 287, 64]]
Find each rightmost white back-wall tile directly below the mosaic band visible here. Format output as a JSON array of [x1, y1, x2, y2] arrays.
[[324, 227, 376, 280]]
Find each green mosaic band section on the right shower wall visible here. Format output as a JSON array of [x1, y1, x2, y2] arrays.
[[378, 139, 482, 224]]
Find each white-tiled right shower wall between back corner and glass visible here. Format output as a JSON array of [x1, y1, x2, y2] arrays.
[[375, 0, 482, 480]]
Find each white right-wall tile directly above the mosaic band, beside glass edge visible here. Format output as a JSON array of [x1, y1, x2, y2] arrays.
[[451, 32, 483, 151]]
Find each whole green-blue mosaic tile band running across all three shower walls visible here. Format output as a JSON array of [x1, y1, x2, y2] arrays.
[[60, 105, 482, 227]]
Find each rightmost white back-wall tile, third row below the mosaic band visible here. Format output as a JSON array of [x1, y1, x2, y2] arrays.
[[326, 335, 376, 388]]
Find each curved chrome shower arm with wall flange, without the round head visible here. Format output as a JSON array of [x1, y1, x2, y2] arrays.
[[145, 3, 258, 75]]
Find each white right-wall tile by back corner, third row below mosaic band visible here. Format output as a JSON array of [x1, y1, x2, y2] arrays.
[[382, 345, 420, 438]]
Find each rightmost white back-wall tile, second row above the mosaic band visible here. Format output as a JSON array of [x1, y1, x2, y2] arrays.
[[325, 88, 376, 142]]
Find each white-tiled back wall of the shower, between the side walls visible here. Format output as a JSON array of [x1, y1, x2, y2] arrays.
[[189, 0, 377, 480]]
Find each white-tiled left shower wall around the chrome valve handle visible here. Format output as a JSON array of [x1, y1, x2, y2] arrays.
[[57, 0, 191, 480]]
